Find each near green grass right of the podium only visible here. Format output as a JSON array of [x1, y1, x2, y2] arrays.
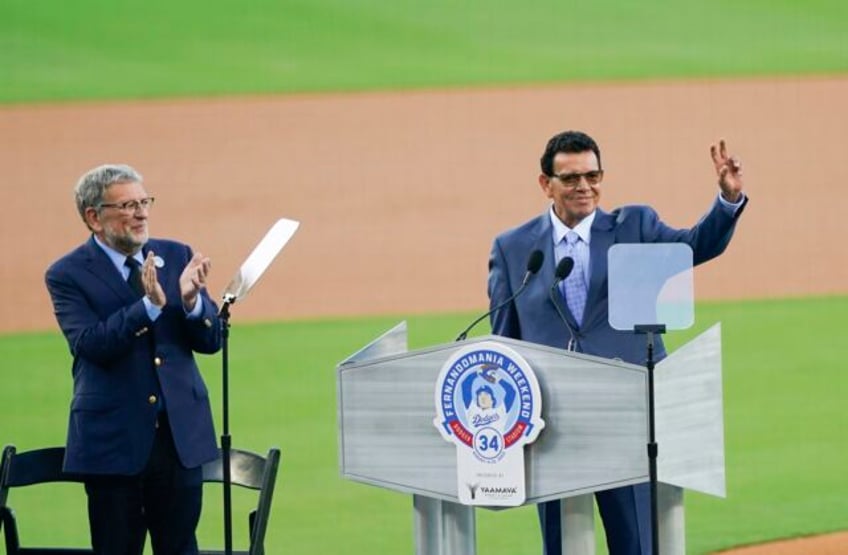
[[669, 298, 848, 553]]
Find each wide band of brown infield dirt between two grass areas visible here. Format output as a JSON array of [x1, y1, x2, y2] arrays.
[[0, 78, 848, 331]]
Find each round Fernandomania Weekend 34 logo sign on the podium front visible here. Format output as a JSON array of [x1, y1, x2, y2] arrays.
[[433, 341, 545, 506]]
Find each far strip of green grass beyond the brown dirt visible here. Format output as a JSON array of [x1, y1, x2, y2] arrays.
[[0, 0, 848, 102]]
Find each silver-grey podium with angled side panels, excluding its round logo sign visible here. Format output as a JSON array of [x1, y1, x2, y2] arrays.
[[337, 323, 725, 555]]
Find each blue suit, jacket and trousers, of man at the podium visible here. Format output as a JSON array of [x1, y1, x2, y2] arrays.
[[488, 200, 747, 555]]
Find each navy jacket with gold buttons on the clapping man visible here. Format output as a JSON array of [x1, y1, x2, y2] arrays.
[[46, 238, 221, 475]]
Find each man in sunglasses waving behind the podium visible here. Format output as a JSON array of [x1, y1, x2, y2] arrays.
[[488, 131, 747, 555]]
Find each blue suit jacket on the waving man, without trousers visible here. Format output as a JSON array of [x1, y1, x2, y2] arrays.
[[489, 199, 747, 364]]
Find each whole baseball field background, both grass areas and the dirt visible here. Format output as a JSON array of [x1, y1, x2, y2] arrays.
[[0, 0, 848, 555]]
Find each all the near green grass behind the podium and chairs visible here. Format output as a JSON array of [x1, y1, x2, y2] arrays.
[[0, 297, 848, 555]]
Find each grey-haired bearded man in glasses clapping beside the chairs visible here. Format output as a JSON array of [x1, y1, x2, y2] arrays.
[[46, 165, 221, 555]]
